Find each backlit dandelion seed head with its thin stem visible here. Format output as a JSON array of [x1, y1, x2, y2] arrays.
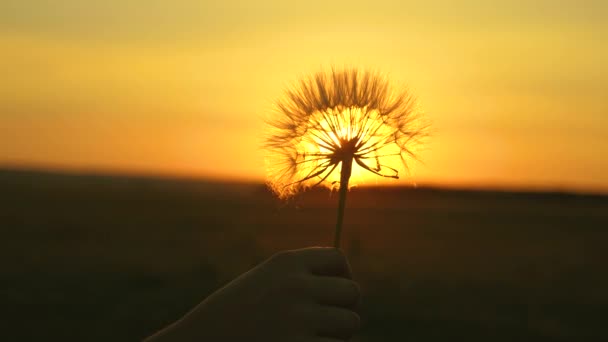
[[265, 69, 424, 248]]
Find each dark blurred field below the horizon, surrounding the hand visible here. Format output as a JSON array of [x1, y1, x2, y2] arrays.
[[0, 170, 608, 341]]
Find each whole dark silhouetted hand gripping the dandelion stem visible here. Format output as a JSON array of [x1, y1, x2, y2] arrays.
[[146, 248, 359, 342]]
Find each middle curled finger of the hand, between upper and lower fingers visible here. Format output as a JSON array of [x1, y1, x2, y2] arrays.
[[310, 276, 361, 308]]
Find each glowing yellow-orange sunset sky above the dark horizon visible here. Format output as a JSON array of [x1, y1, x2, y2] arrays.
[[0, 0, 608, 192]]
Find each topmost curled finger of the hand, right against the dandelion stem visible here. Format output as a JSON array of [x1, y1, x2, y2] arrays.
[[299, 247, 352, 278]]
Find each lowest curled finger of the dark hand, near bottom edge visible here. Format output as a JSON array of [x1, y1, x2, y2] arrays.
[[316, 306, 361, 339]]
